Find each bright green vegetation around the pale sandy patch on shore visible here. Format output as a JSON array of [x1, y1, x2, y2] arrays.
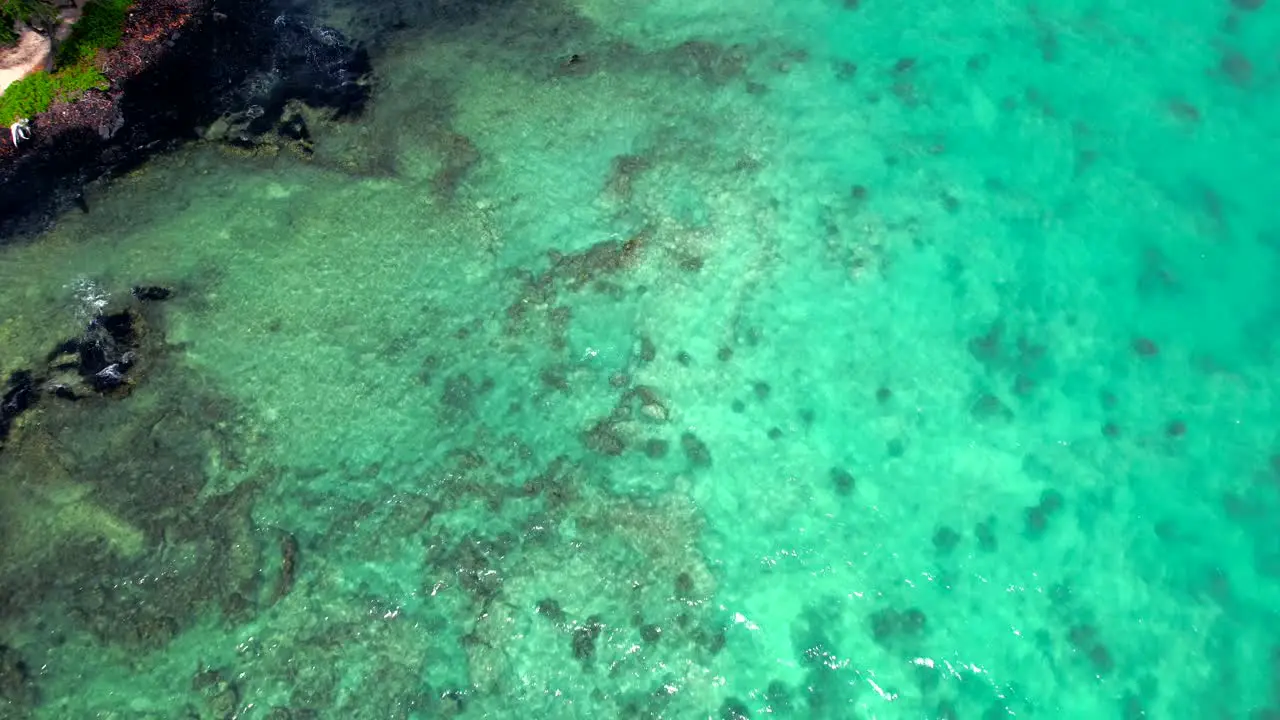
[[0, 0, 133, 127]]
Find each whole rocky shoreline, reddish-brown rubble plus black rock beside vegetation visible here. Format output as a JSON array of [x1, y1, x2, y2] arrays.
[[0, 0, 371, 243]]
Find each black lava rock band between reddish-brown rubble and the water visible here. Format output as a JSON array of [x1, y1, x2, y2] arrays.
[[0, 0, 371, 243]]
